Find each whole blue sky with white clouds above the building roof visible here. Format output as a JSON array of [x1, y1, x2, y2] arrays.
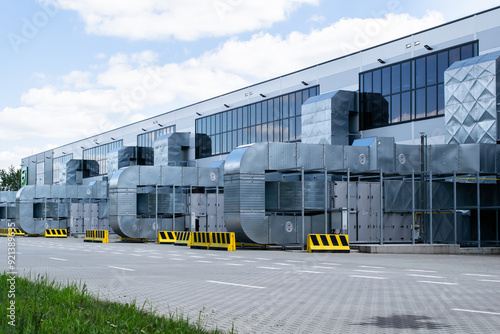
[[0, 0, 500, 169]]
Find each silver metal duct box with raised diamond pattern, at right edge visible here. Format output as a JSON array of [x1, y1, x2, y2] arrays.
[[444, 52, 500, 144]]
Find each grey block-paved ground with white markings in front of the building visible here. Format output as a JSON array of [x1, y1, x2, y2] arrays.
[[0, 237, 500, 333]]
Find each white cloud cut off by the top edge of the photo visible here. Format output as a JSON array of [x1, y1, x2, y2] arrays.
[[52, 0, 319, 40]]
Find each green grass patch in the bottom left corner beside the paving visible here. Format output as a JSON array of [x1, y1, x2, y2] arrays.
[[0, 273, 230, 334]]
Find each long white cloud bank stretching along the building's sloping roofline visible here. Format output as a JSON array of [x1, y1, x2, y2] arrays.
[[0, 10, 443, 168]]
